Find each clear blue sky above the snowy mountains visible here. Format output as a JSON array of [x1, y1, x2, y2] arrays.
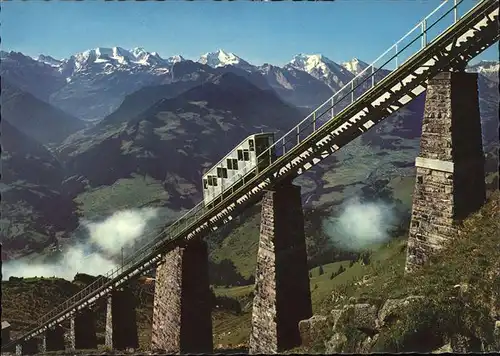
[[0, 0, 498, 65]]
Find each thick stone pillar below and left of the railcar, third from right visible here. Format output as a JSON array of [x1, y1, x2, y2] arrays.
[[151, 239, 213, 353]]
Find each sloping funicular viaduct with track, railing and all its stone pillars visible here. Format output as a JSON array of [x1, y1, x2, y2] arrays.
[[6, 0, 499, 354]]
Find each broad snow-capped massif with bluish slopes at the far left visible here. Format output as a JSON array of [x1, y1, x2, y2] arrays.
[[0, 47, 191, 120]]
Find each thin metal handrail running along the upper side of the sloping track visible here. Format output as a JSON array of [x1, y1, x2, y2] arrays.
[[4, 0, 496, 348]]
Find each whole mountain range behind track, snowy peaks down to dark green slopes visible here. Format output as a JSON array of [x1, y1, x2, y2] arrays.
[[0, 47, 498, 258]]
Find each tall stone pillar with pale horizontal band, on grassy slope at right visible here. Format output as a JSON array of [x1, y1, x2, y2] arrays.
[[405, 72, 486, 272]]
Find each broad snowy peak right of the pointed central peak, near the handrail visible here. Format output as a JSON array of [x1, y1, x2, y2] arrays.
[[285, 53, 354, 91]]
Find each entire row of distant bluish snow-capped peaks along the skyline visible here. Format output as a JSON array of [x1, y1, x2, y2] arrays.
[[0, 47, 499, 120]]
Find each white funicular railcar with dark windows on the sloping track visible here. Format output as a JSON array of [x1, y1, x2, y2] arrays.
[[202, 132, 276, 208]]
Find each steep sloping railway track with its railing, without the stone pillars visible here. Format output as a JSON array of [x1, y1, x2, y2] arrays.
[[3, 0, 499, 349]]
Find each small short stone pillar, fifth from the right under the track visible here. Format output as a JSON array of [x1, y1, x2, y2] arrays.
[[69, 309, 97, 350]]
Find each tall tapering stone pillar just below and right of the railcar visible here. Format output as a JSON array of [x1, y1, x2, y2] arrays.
[[249, 182, 312, 354]]
